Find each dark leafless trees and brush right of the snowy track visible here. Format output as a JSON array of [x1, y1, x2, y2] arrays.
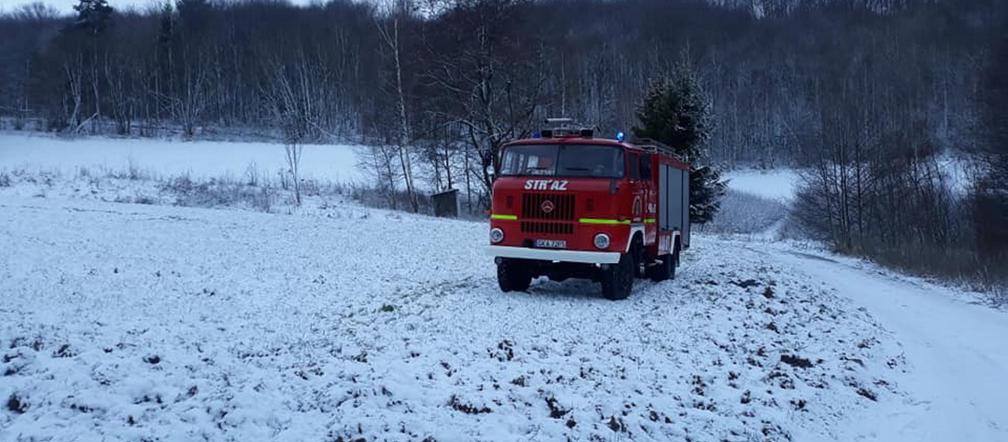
[[793, 4, 1008, 287]]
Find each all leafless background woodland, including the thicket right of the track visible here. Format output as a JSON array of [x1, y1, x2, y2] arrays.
[[0, 0, 1008, 281]]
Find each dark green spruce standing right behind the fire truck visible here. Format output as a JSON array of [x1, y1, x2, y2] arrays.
[[633, 66, 725, 224]]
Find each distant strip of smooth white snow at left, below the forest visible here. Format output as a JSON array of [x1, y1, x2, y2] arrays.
[[0, 132, 364, 182]]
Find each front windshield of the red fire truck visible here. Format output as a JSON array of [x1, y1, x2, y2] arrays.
[[501, 144, 624, 178]]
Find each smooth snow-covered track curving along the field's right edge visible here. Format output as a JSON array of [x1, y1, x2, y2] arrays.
[[762, 242, 1008, 441]]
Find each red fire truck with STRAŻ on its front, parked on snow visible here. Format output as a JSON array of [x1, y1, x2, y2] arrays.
[[487, 119, 689, 300]]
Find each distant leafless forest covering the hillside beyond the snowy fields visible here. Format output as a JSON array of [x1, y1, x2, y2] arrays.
[[0, 0, 1005, 167]]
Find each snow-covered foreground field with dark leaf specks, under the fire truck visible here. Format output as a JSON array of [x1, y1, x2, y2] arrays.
[[0, 133, 1008, 441]]
